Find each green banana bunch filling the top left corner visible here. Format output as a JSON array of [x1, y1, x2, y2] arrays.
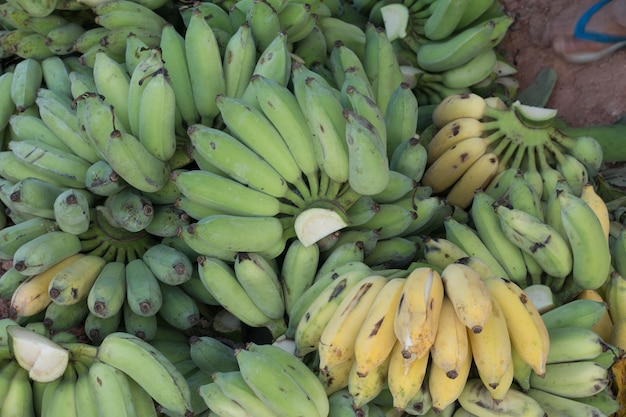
[[0, 0, 169, 63]]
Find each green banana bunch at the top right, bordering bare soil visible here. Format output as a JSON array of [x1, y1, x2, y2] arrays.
[[369, 0, 517, 105]]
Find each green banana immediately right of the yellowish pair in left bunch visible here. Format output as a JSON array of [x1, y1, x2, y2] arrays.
[[87, 262, 126, 318]]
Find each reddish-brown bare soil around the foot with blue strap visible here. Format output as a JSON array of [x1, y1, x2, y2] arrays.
[[0, 0, 626, 312]]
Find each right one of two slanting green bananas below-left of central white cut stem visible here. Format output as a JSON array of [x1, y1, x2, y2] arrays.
[[233, 252, 285, 320]]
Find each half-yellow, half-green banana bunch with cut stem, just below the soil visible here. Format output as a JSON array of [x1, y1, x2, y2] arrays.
[[422, 93, 602, 207]]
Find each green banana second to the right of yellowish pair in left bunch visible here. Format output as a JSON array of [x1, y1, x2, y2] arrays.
[[126, 258, 163, 316]]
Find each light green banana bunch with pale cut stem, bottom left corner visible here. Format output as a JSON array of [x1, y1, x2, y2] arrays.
[[0, 319, 202, 416]]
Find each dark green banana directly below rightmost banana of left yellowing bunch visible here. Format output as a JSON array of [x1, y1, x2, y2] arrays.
[[158, 281, 200, 330]]
